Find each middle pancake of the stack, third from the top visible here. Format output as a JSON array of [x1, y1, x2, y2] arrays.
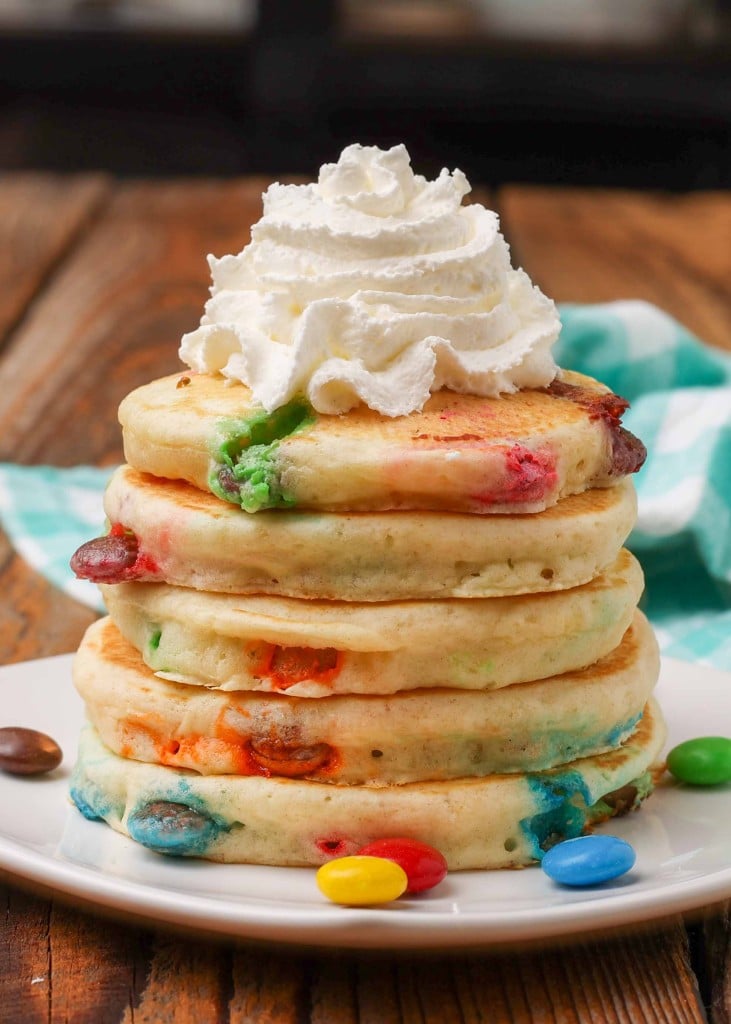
[[101, 549, 643, 697]]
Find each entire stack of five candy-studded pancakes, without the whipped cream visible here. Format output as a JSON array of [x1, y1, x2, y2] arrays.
[[72, 373, 664, 868]]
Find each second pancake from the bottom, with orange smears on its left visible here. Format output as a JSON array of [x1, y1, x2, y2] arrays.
[[74, 612, 659, 785]]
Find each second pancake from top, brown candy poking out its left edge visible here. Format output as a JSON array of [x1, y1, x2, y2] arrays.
[[72, 466, 636, 601]]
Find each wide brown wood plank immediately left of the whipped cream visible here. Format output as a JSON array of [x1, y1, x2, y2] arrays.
[[0, 179, 270, 466]]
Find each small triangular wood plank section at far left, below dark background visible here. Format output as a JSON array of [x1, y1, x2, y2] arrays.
[[0, 174, 111, 348]]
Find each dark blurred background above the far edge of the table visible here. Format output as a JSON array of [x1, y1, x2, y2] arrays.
[[0, 0, 731, 189]]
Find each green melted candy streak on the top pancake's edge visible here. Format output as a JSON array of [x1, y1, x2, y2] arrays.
[[209, 398, 316, 512]]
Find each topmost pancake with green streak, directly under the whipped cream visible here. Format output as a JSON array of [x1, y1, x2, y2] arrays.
[[120, 373, 644, 513]]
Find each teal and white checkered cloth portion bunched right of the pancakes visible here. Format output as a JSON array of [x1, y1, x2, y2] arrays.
[[556, 302, 731, 669]]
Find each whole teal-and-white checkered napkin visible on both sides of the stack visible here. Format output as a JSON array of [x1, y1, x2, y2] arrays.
[[0, 302, 731, 670]]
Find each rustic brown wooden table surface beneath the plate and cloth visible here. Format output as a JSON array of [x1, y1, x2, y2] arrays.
[[0, 174, 731, 1024]]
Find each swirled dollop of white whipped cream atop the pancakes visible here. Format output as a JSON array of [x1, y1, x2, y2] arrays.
[[180, 145, 560, 416]]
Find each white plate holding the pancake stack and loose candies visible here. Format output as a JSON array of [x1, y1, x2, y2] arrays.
[[0, 655, 731, 949]]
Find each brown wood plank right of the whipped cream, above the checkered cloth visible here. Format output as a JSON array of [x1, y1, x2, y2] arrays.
[[498, 185, 731, 350]]
